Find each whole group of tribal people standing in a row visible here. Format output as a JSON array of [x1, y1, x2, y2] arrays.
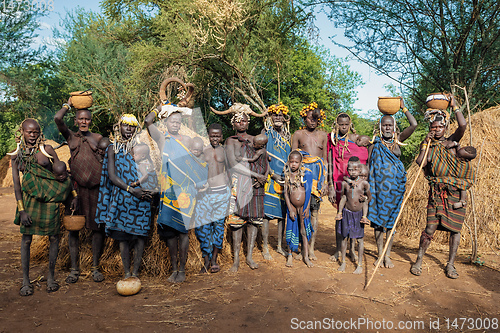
[[10, 92, 471, 296]]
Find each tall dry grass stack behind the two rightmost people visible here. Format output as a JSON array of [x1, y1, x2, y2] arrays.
[[398, 107, 500, 251]]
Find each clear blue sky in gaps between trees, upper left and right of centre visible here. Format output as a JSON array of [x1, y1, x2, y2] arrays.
[[34, 0, 395, 116]]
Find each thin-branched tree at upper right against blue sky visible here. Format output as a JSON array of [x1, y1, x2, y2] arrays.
[[318, 0, 500, 110]]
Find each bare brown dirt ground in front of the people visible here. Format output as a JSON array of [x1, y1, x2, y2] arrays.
[[0, 189, 500, 332]]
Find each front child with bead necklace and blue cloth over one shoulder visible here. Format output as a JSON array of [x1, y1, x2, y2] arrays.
[[284, 150, 313, 267]]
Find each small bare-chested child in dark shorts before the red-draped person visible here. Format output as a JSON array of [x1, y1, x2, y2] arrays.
[[336, 156, 371, 274]]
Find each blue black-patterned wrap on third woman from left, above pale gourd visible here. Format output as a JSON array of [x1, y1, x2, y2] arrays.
[[95, 145, 151, 236]]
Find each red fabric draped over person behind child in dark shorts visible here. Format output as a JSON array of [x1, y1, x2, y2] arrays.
[[328, 134, 368, 206]]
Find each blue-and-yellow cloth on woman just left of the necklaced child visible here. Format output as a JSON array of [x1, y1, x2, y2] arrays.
[[264, 128, 291, 219]]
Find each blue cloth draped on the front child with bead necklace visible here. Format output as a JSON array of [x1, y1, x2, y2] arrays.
[[286, 167, 314, 252]]
